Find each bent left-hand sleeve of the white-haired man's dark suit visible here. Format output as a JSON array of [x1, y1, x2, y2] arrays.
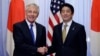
[[13, 25, 37, 54]]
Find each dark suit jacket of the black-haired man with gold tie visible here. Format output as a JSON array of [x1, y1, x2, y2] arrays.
[[48, 21, 87, 56]]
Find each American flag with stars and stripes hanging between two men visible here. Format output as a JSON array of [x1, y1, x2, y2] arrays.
[[47, 0, 65, 49]]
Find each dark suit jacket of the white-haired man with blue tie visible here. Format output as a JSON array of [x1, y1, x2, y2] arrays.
[[13, 20, 46, 56]]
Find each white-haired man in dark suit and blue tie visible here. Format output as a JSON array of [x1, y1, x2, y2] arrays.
[[13, 3, 46, 56]]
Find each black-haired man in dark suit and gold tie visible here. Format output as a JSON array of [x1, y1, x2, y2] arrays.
[[48, 3, 87, 56]]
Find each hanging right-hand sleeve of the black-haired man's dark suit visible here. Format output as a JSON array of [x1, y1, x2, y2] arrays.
[[79, 27, 87, 56]]
